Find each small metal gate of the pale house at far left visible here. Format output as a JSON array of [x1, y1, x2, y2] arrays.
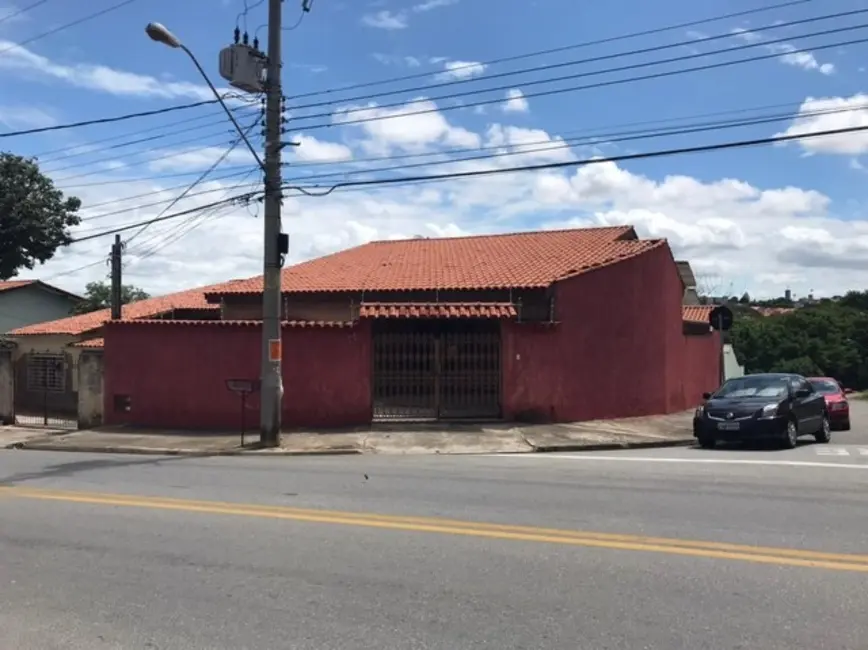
[[14, 352, 78, 429]]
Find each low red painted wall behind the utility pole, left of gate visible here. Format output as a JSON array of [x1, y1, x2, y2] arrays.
[[105, 322, 371, 430]]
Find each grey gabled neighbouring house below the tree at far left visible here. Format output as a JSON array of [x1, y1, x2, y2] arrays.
[[0, 280, 83, 334]]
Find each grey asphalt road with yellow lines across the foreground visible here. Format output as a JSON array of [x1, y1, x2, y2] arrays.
[[0, 402, 868, 650]]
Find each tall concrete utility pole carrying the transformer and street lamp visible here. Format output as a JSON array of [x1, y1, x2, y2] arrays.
[[259, 0, 283, 447]]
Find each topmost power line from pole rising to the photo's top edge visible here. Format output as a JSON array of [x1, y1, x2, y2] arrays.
[[293, 0, 813, 101]]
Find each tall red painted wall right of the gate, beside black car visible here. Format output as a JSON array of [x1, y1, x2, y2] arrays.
[[503, 247, 718, 422]]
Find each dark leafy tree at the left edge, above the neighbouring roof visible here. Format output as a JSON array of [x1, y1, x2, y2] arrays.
[[0, 152, 81, 280]]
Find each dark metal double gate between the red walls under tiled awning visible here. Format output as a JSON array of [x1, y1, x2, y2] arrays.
[[373, 320, 501, 421]]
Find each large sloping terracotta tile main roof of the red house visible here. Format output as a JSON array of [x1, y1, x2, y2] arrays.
[[208, 226, 652, 299]]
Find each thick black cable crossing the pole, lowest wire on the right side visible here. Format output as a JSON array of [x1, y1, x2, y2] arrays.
[[70, 121, 868, 244]]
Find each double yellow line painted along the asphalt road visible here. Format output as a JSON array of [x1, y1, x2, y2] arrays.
[[0, 487, 868, 573]]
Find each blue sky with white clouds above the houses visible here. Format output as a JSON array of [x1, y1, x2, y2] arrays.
[[0, 0, 868, 297]]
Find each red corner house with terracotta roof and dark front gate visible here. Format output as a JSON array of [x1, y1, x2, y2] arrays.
[[104, 226, 719, 429]]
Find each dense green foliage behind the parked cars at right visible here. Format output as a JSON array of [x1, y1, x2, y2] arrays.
[[731, 291, 868, 389]]
